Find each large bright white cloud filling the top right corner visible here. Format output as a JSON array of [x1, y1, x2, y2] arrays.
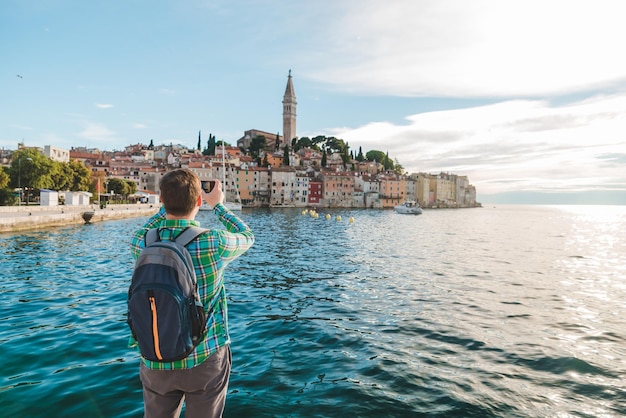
[[301, 0, 626, 97]]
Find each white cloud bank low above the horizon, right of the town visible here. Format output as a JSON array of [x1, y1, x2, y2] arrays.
[[333, 94, 626, 193]]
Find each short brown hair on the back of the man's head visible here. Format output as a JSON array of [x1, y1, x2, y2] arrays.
[[159, 169, 201, 216]]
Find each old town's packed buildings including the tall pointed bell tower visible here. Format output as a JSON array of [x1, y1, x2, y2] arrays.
[[0, 70, 480, 209]]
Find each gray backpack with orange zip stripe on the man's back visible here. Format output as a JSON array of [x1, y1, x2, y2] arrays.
[[127, 227, 208, 362]]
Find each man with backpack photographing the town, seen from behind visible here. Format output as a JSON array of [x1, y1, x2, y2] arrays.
[[128, 169, 254, 418]]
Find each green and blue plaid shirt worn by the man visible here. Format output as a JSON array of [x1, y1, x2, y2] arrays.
[[129, 204, 254, 370]]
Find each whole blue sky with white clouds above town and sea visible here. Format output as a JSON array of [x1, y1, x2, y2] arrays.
[[0, 0, 626, 204]]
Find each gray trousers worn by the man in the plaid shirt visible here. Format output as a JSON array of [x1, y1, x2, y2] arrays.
[[139, 345, 232, 418]]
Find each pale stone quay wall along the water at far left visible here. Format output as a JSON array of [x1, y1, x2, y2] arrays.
[[0, 203, 159, 233]]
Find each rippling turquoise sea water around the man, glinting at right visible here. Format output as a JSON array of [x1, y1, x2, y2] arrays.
[[0, 206, 626, 418]]
